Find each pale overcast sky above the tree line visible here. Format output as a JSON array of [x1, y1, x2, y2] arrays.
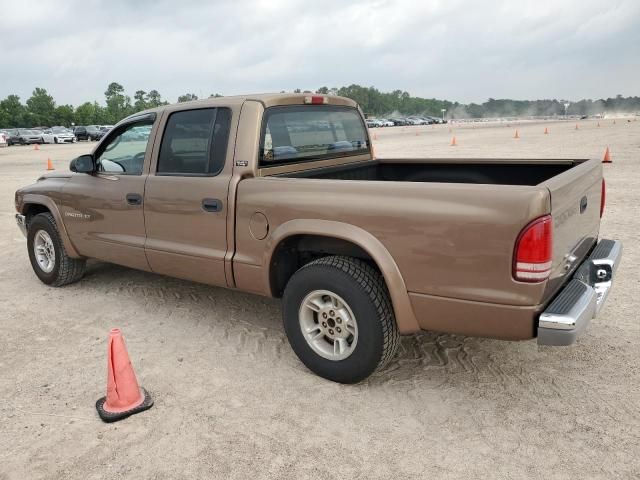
[[0, 0, 640, 105]]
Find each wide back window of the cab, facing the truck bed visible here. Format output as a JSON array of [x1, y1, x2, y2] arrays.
[[260, 105, 370, 167]]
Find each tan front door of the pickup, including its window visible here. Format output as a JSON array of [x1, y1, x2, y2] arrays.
[[62, 115, 155, 270]]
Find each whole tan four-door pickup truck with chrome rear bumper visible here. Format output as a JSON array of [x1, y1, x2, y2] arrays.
[[15, 94, 622, 383]]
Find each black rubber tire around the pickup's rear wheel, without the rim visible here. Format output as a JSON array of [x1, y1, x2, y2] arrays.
[[283, 256, 399, 383]]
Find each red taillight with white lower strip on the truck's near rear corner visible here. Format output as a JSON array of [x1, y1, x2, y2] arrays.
[[513, 215, 553, 282]]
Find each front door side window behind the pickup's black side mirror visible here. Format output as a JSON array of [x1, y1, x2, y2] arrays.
[[96, 121, 153, 175]]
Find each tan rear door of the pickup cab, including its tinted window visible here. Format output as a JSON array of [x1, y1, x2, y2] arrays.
[[144, 107, 233, 286]]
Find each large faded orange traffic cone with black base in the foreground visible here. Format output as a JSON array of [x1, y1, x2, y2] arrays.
[[96, 328, 153, 423]]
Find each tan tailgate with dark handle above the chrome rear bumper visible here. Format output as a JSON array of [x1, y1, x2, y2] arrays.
[[541, 160, 602, 302]]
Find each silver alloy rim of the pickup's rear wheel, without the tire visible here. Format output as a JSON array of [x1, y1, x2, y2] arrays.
[[298, 290, 358, 362]]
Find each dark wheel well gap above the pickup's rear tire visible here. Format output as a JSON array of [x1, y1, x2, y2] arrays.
[[269, 235, 380, 298]]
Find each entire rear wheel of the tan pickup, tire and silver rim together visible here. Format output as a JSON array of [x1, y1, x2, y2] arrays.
[[283, 256, 399, 383]]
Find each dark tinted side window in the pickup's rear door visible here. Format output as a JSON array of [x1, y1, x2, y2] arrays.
[[157, 108, 231, 176]]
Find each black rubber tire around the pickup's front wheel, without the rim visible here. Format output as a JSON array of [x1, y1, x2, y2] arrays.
[[27, 213, 86, 287]]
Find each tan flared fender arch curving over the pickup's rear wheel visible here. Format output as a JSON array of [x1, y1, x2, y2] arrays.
[[262, 219, 420, 334]]
